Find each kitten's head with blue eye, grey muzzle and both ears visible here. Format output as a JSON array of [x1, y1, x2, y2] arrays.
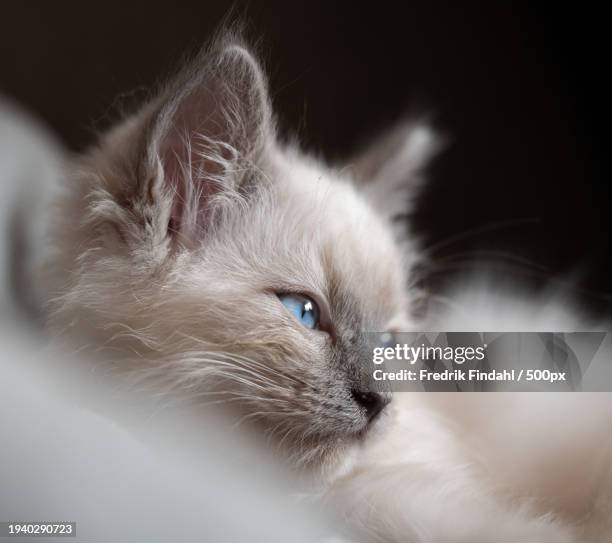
[[51, 35, 434, 476]]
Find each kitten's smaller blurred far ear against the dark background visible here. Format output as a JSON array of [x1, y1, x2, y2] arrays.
[[348, 121, 442, 220]]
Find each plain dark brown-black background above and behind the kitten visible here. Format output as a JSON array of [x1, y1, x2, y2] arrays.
[[0, 0, 612, 309]]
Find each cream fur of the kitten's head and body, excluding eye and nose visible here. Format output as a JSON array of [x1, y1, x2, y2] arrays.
[[19, 36, 611, 543]]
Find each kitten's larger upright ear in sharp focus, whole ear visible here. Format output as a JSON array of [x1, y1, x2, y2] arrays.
[[137, 40, 274, 242]]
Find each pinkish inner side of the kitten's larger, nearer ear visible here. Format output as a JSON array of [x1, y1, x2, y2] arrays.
[[146, 46, 272, 241]]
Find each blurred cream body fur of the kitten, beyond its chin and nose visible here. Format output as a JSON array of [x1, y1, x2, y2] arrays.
[[330, 306, 612, 542]]
